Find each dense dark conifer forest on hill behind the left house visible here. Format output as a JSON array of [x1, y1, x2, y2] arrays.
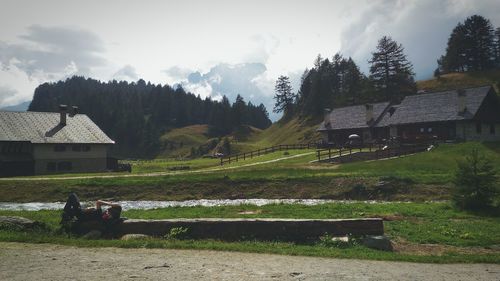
[[28, 76, 271, 157]]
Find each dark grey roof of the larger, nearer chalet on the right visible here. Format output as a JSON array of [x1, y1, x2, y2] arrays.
[[376, 86, 491, 127]]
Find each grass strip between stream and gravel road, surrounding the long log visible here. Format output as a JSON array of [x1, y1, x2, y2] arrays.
[[0, 203, 500, 263]]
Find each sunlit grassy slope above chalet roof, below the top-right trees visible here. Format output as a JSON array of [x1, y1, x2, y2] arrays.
[[417, 70, 500, 93]]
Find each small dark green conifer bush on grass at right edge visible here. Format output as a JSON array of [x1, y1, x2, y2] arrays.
[[452, 149, 498, 210]]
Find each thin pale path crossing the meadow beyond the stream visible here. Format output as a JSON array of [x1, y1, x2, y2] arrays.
[[0, 152, 314, 181]]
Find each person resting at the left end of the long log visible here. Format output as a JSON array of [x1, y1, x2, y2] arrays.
[[61, 193, 122, 224]]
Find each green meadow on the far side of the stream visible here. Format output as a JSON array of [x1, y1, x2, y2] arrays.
[[0, 142, 500, 202]]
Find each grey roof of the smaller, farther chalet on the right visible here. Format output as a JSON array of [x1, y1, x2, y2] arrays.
[[318, 102, 389, 131]]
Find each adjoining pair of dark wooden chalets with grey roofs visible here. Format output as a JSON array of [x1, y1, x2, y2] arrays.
[[318, 86, 500, 145]]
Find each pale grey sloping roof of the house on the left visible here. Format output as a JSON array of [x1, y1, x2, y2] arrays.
[[0, 111, 115, 144]]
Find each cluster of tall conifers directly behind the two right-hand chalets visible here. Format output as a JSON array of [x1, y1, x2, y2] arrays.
[[274, 36, 417, 117]]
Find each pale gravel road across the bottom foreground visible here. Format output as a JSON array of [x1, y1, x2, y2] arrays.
[[0, 243, 500, 280]]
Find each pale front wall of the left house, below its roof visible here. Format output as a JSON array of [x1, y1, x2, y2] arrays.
[[33, 144, 107, 175]]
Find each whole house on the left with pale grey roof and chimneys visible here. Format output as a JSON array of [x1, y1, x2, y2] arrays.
[[0, 105, 114, 176]]
